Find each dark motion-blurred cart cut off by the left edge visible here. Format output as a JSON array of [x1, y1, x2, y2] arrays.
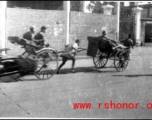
[[0, 48, 36, 77]]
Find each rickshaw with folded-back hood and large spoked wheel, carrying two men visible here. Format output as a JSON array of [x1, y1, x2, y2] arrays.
[[6, 36, 58, 80]]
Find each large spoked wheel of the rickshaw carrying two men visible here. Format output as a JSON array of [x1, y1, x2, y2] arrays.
[[34, 50, 58, 80]]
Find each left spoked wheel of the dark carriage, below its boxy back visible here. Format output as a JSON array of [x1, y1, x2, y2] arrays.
[[93, 50, 108, 68]]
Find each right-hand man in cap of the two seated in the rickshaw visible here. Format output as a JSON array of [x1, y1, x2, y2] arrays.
[[34, 25, 47, 46]]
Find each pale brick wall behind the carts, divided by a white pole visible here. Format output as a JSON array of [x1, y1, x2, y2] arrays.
[[6, 8, 117, 56]]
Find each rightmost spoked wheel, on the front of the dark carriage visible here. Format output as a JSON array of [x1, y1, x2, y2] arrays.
[[114, 51, 129, 72]]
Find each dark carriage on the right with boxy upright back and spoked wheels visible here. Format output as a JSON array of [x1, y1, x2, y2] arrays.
[[87, 36, 129, 71]]
